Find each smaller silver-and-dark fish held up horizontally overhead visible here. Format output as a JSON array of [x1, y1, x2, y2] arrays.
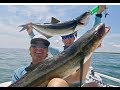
[[20, 11, 90, 38]]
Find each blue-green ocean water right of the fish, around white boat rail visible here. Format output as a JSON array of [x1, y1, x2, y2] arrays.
[[91, 53, 120, 86]]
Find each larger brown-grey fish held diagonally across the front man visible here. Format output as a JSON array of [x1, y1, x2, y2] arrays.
[[9, 23, 109, 87]]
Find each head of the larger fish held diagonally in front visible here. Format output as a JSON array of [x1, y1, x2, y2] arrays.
[[82, 23, 110, 55]]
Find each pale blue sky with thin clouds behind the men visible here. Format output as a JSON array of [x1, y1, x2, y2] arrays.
[[0, 3, 120, 53]]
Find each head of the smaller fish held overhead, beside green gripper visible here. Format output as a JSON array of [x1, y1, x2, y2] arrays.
[[76, 11, 90, 25]]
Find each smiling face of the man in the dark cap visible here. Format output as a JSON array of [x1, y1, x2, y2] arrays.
[[30, 47, 48, 64]]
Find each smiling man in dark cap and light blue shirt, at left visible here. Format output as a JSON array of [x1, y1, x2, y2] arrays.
[[12, 38, 50, 82]]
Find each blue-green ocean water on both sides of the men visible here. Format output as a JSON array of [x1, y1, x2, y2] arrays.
[[0, 48, 120, 86]]
